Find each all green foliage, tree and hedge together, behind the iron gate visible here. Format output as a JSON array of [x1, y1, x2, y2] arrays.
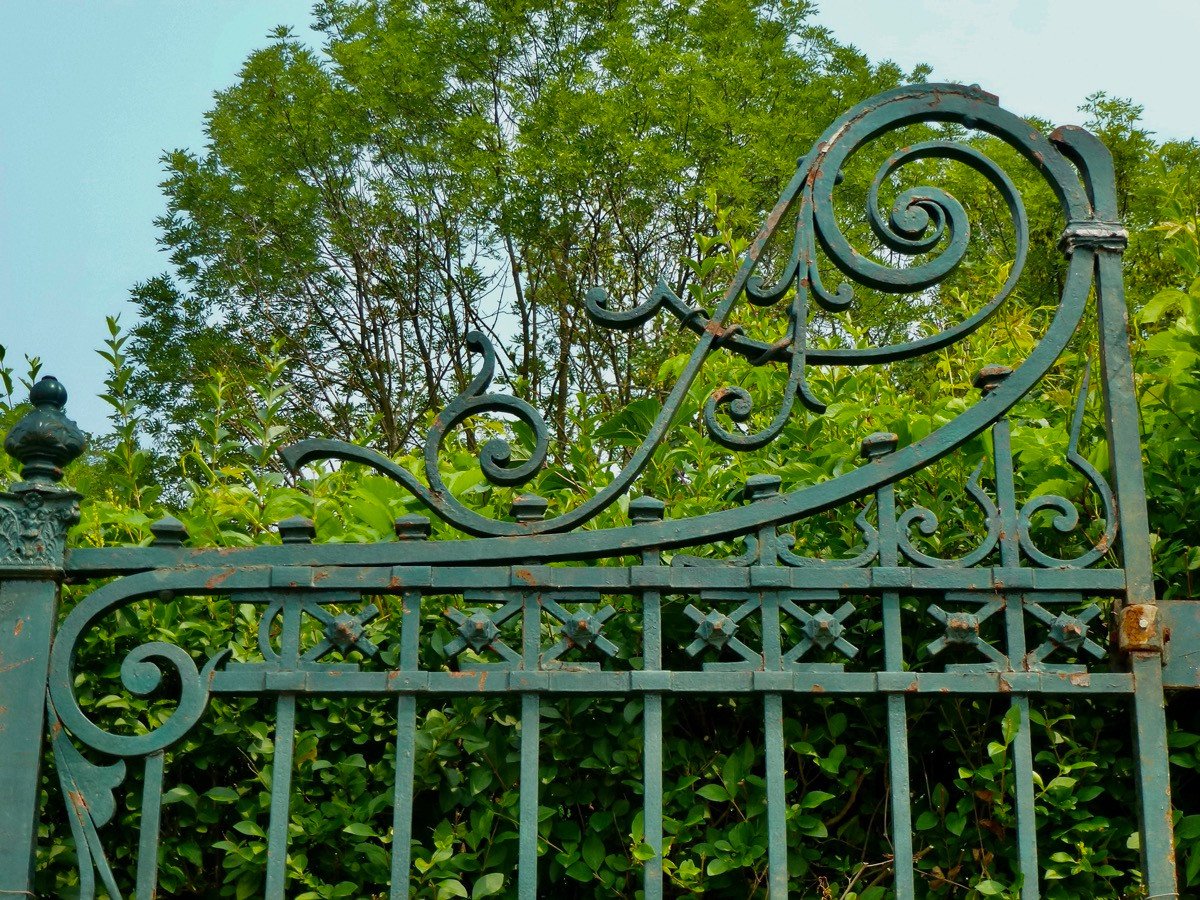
[[0, 0, 1200, 900]]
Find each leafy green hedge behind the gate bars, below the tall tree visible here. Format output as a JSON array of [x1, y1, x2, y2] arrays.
[[7, 248, 1200, 899]]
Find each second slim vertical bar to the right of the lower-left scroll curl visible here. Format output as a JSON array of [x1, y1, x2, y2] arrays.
[[391, 590, 421, 900]]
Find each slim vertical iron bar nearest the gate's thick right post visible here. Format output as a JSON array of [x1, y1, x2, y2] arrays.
[[983, 410, 1042, 900]]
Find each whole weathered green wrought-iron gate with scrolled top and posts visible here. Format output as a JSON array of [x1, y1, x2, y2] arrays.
[[0, 84, 1185, 898]]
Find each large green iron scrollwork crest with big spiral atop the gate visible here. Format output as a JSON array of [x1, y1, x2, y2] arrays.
[[283, 84, 1106, 558]]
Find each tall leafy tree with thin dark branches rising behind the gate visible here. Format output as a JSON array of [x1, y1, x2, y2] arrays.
[[130, 0, 922, 452]]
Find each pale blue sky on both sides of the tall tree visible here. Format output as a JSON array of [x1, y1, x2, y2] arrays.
[[0, 0, 1200, 431]]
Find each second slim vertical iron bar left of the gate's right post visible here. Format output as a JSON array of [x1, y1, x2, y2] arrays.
[[875, 453, 917, 898]]
